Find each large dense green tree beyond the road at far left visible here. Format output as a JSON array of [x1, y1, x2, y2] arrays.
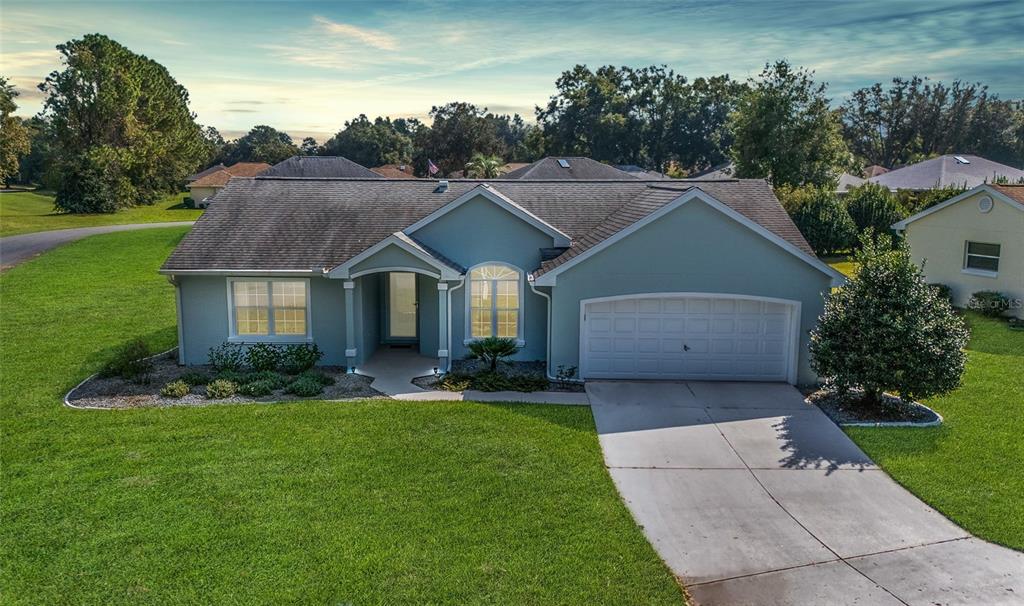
[[39, 34, 207, 212]]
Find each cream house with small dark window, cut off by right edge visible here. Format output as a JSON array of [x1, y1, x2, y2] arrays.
[[893, 185, 1024, 317]]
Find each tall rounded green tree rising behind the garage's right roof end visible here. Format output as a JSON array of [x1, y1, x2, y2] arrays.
[[730, 60, 852, 187]]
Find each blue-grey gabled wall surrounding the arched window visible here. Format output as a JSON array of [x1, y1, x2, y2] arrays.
[[407, 197, 553, 360]]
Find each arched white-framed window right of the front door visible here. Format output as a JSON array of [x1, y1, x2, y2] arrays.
[[467, 263, 522, 339]]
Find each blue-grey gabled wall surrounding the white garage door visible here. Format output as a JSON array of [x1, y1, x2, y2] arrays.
[[549, 200, 830, 383]]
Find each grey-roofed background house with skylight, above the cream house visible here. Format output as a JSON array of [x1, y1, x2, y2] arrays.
[[867, 154, 1024, 191]]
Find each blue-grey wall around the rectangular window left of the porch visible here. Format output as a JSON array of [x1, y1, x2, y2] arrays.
[[177, 275, 345, 365]]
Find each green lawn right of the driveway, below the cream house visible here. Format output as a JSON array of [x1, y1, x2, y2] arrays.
[[847, 312, 1024, 550]]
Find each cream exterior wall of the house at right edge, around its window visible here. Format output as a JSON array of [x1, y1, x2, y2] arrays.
[[906, 191, 1024, 317]]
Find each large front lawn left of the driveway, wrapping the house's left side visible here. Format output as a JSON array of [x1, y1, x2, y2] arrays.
[[0, 229, 683, 604]]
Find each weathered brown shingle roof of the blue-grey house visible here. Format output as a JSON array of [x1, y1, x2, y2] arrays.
[[163, 177, 813, 271]]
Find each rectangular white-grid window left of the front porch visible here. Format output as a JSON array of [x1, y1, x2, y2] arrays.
[[230, 279, 309, 337]]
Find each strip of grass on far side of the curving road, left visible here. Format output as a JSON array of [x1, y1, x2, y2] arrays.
[[0, 191, 203, 236]]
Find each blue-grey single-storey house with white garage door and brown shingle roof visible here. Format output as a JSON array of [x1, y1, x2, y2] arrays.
[[160, 177, 842, 383]]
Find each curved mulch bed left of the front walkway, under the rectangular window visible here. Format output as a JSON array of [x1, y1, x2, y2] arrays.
[[68, 352, 387, 408]]
